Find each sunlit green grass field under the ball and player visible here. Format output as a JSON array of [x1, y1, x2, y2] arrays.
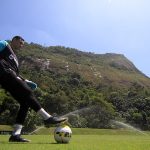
[[0, 128, 150, 150]]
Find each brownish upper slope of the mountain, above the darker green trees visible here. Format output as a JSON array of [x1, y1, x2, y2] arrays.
[[19, 43, 150, 88]]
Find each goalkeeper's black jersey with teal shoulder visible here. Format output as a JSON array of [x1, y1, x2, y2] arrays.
[[0, 40, 18, 74]]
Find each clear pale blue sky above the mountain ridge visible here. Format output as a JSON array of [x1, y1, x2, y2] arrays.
[[0, 0, 150, 77]]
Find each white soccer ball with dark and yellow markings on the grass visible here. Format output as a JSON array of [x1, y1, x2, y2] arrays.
[[54, 125, 72, 143]]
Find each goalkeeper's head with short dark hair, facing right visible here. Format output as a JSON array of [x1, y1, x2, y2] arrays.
[[11, 36, 24, 50]]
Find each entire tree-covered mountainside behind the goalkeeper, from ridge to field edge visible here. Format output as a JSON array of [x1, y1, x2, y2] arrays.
[[0, 43, 150, 130]]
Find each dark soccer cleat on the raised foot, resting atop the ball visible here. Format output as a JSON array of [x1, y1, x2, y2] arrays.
[[44, 117, 68, 127]]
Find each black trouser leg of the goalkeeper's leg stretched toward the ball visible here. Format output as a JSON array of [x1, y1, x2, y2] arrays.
[[0, 69, 41, 111]]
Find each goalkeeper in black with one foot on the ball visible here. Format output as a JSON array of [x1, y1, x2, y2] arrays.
[[0, 36, 66, 142]]
